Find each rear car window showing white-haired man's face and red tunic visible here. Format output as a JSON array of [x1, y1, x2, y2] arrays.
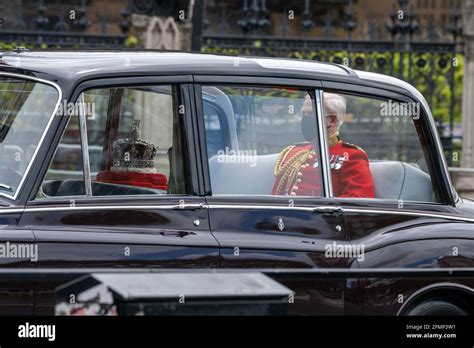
[[323, 91, 438, 202]]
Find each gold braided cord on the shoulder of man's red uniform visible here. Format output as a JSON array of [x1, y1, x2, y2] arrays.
[[275, 149, 314, 195]]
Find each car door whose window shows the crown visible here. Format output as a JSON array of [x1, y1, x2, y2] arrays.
[[21, 77, 218, 312]]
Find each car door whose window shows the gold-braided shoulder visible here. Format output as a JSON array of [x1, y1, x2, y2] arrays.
[[195, 76, 354, 314]]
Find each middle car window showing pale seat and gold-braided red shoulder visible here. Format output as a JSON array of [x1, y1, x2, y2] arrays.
[[203, 86, 322, 197]]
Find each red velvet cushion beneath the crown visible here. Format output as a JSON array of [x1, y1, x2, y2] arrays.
[[96, 170, 168, 191]]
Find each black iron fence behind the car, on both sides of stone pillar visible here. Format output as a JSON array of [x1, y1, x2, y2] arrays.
[[0, 0, 464, 165]]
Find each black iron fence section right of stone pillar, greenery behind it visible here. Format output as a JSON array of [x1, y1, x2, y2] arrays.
[[202, 0, 464, 165]]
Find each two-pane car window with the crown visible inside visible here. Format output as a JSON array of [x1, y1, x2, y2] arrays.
[[38, 86, 187, 197]]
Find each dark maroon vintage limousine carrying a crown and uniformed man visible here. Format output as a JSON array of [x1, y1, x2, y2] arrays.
[[0, 50, 474, 315]]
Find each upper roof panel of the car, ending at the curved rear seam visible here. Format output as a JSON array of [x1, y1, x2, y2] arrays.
[[1, 50, 351, 77]]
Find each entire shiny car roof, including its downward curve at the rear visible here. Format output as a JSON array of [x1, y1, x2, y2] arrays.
[[0, 49, 414, 96]]
